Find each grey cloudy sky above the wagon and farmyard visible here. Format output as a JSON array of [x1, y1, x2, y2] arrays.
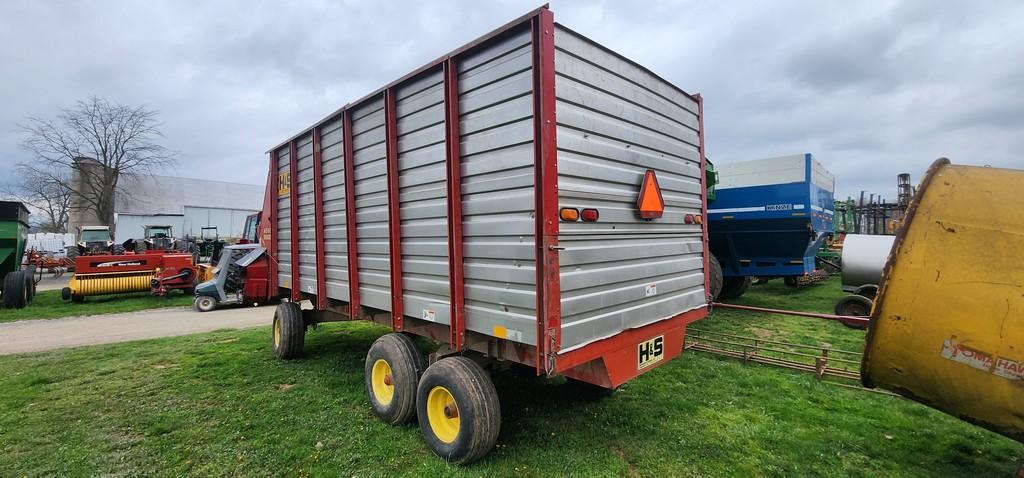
[[0, 0, 1024, 198]]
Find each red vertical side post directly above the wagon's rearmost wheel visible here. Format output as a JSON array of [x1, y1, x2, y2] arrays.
[[443, 58, 466, 350]]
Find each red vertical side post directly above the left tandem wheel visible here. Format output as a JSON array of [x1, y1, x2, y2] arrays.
[[384, 88, 404, 331]]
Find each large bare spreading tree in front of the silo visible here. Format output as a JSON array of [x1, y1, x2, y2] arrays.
[[18, 96, 175, 228]]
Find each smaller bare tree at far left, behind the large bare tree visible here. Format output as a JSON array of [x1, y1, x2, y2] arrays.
[[7, 165, 71, 232]]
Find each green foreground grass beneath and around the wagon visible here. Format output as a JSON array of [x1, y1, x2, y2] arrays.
[[0, 283, 1024, 477]]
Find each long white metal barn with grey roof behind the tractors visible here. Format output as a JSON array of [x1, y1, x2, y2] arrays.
[[114, 175, 264, 243]]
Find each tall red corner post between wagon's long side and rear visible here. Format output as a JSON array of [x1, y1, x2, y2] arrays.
[[531, 8, 561, 374]]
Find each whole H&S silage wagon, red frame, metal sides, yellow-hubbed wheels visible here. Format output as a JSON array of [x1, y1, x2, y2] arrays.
[[260, 7, 708, 463]]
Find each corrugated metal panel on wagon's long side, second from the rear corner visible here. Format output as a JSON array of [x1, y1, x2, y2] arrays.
[[395, 70, 451, 323]]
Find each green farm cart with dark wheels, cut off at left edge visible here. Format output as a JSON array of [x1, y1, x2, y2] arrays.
[[0, 201, 36, 309]]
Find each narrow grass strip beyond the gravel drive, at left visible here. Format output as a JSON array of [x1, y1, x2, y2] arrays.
[[0, 291, 193, 322]]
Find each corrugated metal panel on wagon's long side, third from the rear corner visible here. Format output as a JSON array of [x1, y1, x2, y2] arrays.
[[352, 96, 391, 311]]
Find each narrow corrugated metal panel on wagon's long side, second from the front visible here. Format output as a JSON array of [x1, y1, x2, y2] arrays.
[[295, 135, 316, 294]]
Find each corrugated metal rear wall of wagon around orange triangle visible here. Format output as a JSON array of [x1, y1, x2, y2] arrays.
[[555, 27, 706, 351]]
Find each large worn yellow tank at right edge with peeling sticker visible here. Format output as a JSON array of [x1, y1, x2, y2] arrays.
[[861, 159, 1024, 441]]
